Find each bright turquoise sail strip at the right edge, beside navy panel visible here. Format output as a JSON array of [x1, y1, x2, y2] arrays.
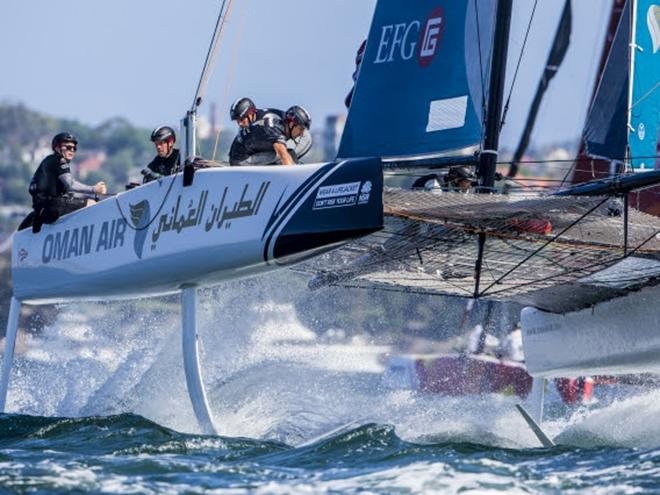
[[628, 0, 660, 171]]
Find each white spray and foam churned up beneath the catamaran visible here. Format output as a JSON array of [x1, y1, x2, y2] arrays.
[[2, 272, 660, 448]]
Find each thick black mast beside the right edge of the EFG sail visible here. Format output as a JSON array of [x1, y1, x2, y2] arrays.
[[477, 0, 513, 193]]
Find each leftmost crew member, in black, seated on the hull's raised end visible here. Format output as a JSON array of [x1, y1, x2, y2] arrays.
[[22, 132, 106, 232]]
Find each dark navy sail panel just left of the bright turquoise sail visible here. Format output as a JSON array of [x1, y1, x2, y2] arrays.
[[584, 0, 630, 162]]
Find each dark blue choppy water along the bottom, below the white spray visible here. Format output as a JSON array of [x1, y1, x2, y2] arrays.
[[0, 414, 660, 493]]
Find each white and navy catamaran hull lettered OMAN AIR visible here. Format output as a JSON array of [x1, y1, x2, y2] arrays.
[[12, 159, 383, 303]]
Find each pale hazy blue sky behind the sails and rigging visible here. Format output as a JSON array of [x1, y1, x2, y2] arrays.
[[0, 0, 611, 151]]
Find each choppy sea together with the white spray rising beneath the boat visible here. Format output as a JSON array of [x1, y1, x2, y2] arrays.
[[0, 278, 660, 494]]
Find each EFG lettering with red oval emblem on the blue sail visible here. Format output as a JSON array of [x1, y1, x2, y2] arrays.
[[373, 7, 445, 68]]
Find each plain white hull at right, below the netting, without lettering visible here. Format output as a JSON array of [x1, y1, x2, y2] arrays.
[[521, 280, 660, 378]]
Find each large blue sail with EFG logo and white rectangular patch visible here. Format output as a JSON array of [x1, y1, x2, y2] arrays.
[[338, 0, 495, 158]]
